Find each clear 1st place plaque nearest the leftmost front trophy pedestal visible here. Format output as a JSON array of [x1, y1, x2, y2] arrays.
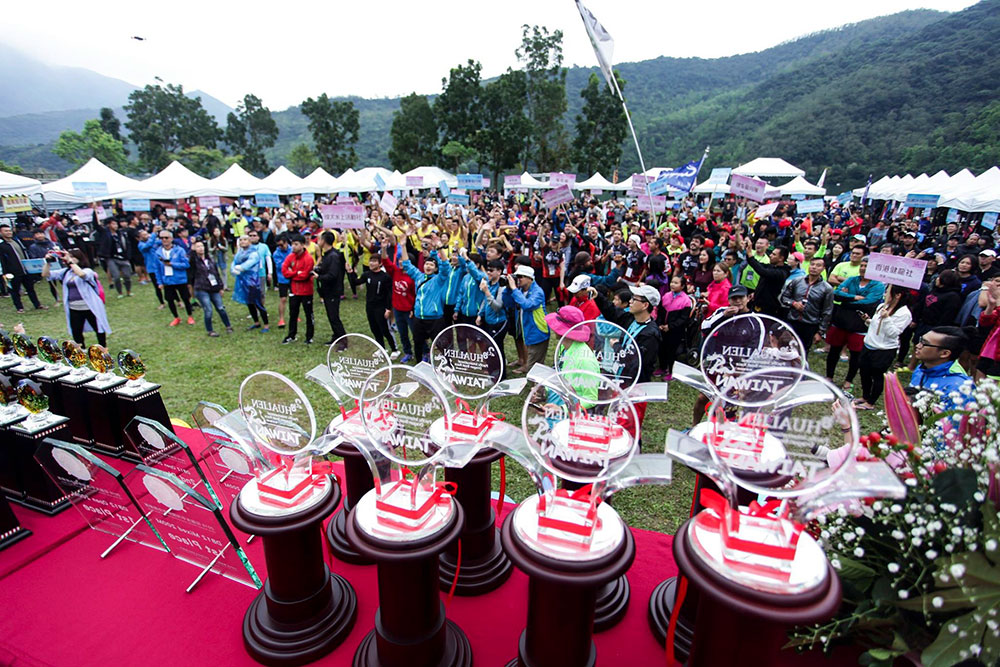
[[126, 464, 263, 592]]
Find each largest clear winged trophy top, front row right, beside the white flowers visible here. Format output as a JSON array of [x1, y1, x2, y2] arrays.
[[667, 367, 905, 594]]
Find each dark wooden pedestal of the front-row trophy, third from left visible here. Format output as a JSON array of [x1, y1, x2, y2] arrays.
[[500, 510, 635, 667]]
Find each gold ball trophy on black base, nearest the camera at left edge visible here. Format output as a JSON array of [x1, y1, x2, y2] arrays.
[[6, 379, 69, 515]]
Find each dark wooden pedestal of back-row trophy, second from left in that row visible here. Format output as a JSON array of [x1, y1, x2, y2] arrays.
[[441, 449, 514, 595]]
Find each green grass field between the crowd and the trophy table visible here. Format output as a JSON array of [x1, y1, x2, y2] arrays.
[[0, 285, 884, 533]]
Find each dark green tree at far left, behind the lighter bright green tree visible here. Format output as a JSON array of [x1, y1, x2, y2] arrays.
[[125, 84, 222, 170]]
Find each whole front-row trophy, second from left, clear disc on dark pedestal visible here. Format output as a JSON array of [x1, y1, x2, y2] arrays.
[[347, 366, 482, 667]]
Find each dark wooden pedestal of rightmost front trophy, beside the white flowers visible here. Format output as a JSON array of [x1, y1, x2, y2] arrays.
[[673, 519, 841, 667]]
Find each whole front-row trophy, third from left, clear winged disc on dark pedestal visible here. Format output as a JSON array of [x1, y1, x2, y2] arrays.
[[492, 368, 672, 667]]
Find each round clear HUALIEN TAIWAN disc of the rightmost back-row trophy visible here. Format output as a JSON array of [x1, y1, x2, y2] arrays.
[[700, 313, 806, 405]]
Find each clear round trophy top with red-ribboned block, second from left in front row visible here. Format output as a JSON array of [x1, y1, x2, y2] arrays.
[[356, 366, 472, 541]]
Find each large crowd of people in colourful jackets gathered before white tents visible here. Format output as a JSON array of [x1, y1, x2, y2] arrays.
[[0, 185, 1000, 410]]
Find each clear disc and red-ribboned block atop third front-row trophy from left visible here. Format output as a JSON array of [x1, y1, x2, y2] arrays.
[[513, 368, 640, 560]]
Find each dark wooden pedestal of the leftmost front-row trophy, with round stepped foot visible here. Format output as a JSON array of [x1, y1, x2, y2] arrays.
[[230, 480, 358, 667]]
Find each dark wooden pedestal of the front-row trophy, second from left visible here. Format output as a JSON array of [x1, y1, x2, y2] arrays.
[[347, 503, 472, 667]]
